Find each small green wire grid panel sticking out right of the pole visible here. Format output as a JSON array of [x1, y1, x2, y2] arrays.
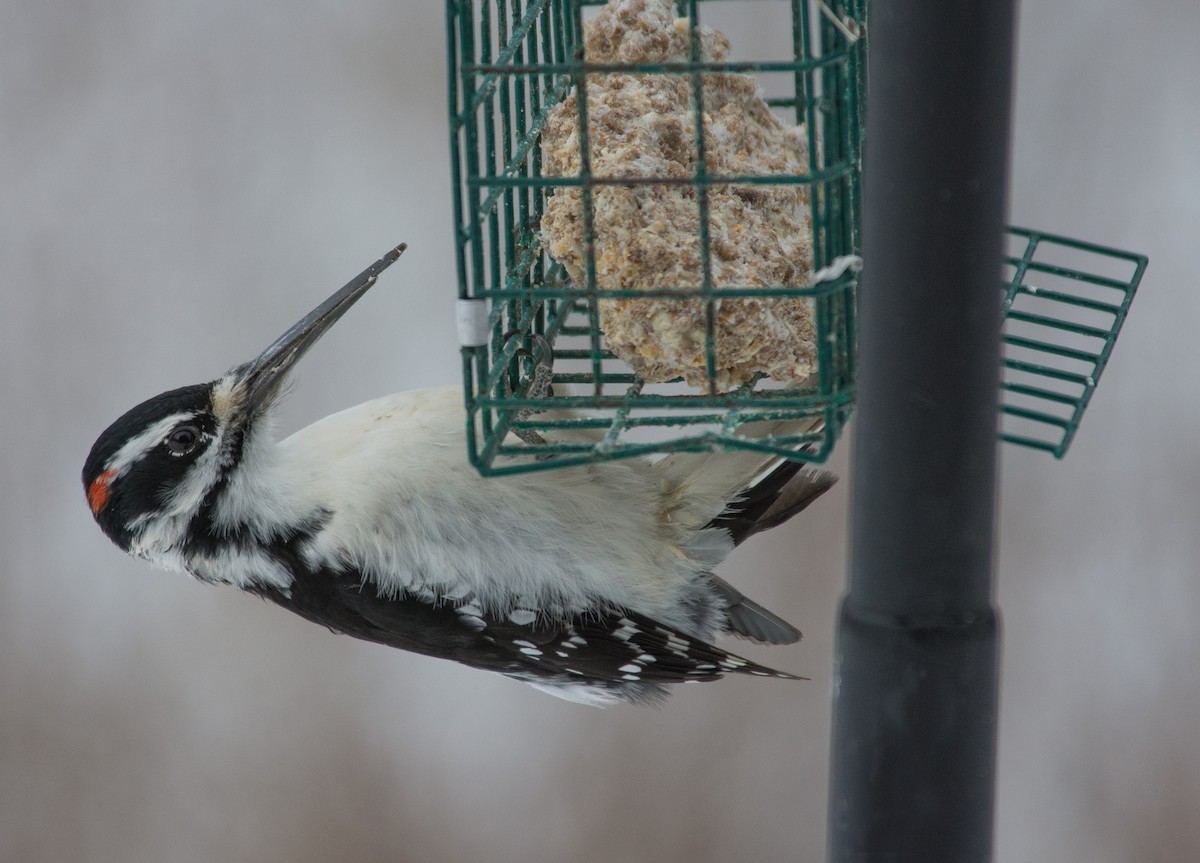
[[1000, 228, 1147, 459]]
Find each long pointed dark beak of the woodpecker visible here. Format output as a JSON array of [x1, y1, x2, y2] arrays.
[[232, 242, 408, 418]]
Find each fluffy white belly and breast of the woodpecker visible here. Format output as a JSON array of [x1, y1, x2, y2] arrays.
[[278, 386, 730, 623]]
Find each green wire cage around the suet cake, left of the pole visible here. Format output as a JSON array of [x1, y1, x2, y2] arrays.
[[446, 0, 864, 473]]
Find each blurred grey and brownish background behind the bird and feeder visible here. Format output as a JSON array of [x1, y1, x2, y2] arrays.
[[0, 0, 1200, 863]]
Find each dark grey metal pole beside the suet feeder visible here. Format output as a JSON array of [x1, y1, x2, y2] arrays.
[[829, 0, 1014, 863]]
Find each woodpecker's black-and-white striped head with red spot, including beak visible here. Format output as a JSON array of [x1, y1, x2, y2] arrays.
[[83, 245, 404, 569]]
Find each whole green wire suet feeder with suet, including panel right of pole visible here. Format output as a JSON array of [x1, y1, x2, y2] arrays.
[[446, 0, 1145, 474]]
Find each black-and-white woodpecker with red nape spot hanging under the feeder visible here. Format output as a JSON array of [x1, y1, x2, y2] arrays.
[[83, 245, 835, 705]]
